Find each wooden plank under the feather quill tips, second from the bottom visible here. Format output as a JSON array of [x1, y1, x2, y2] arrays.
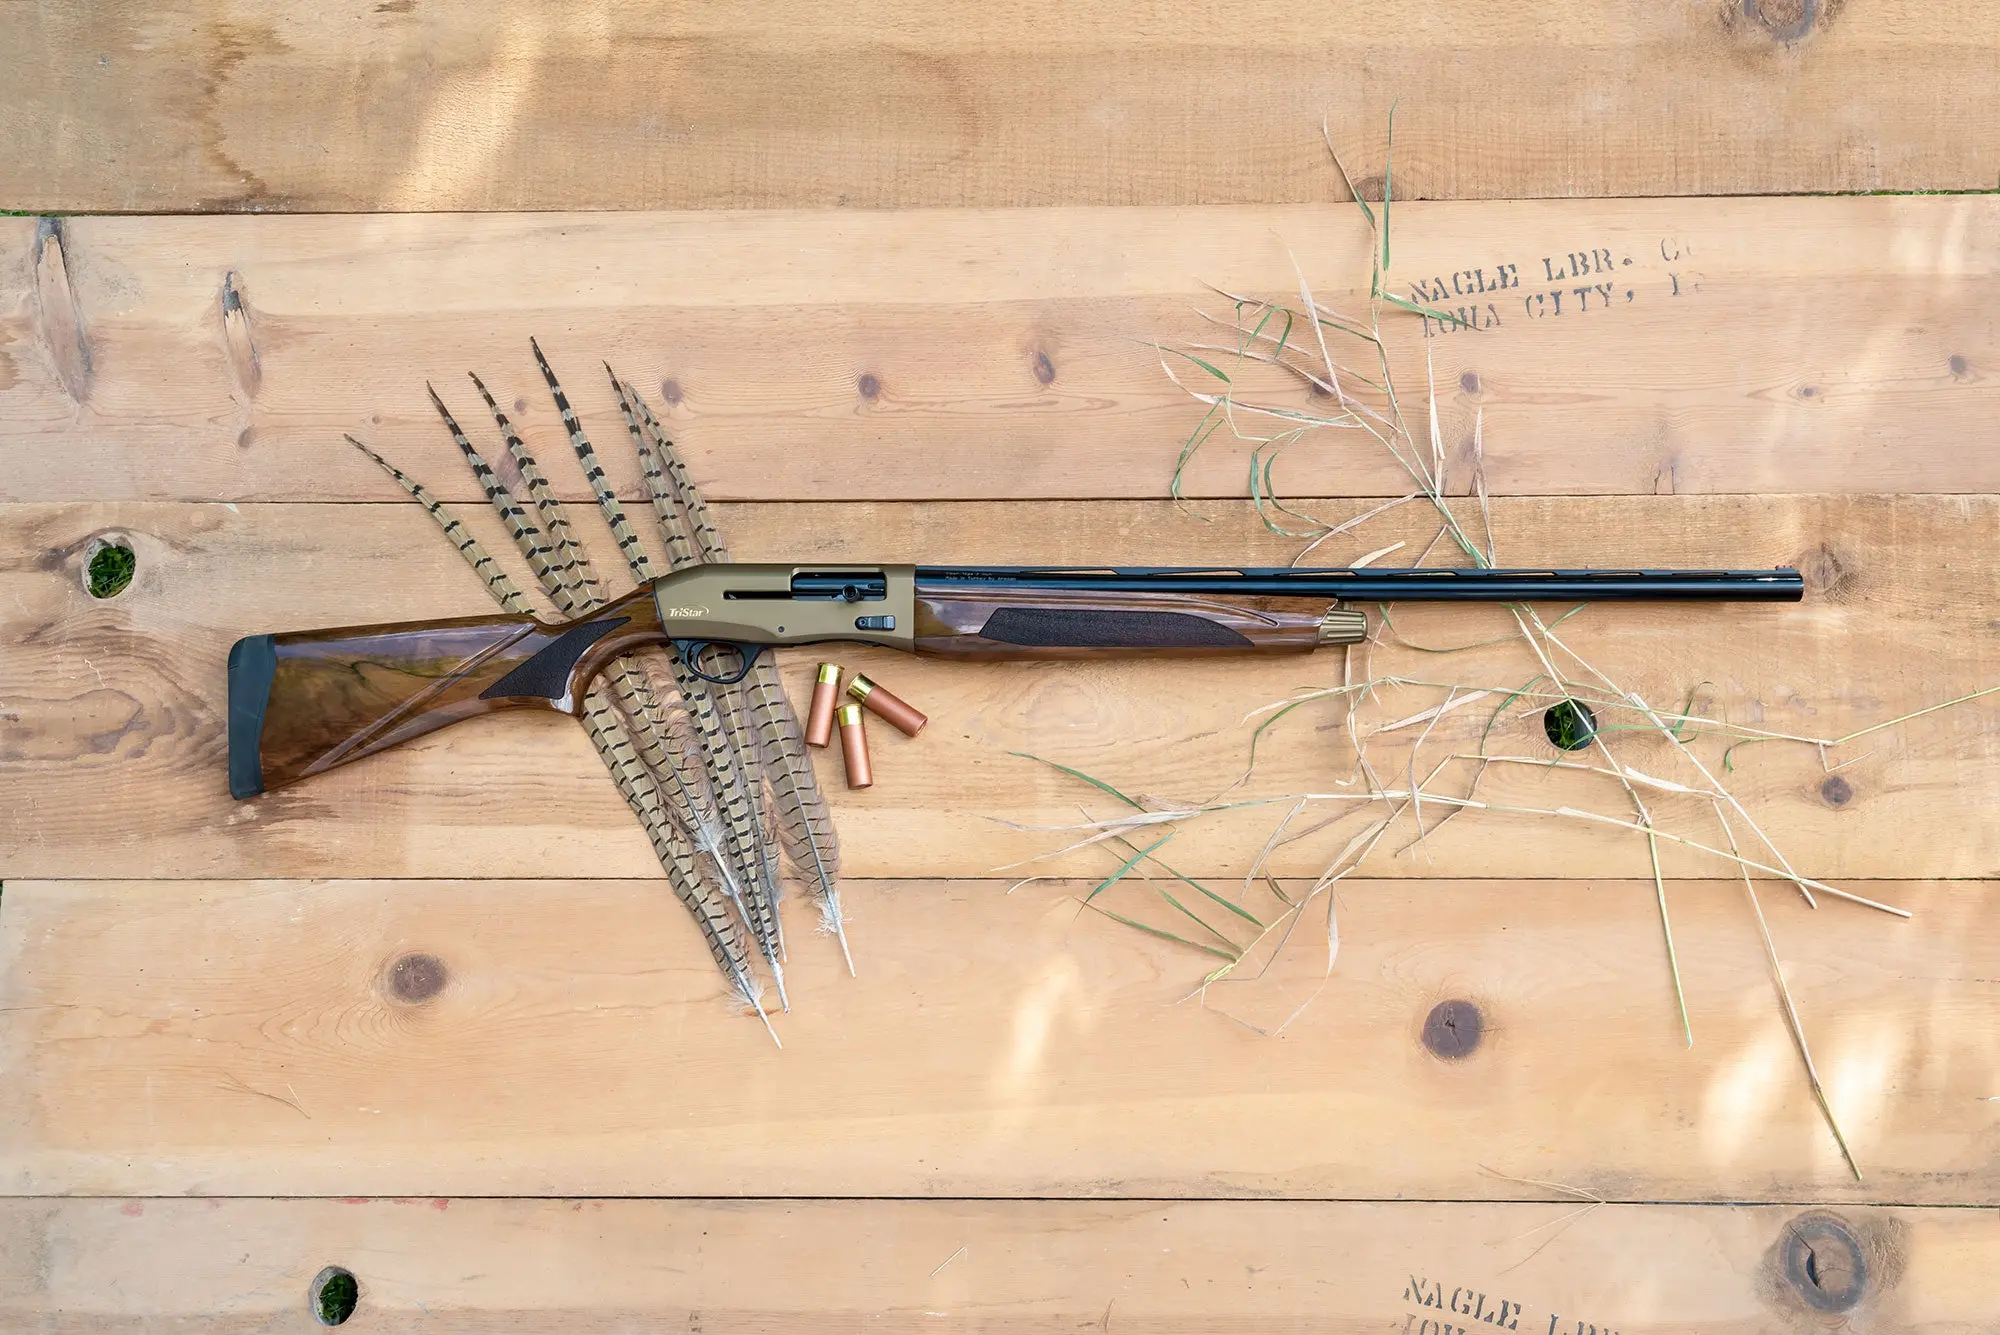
[[0, 881, 2000, 1199]]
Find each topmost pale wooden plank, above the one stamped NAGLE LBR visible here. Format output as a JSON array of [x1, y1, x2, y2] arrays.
[[0, 0, 2000, 212]]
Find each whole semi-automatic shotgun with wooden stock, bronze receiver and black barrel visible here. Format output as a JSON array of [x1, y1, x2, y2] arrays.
[[228, 562, 1804, 797]]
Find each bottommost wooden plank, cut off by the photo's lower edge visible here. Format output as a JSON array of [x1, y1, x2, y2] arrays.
[[0, 1199, 1976, 1335]]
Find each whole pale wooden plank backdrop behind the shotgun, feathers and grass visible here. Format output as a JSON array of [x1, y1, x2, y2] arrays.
[[0, 0, 2000, 1295]]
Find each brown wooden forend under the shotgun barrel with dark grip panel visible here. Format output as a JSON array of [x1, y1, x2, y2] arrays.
[[916, 582, 1366, 660]]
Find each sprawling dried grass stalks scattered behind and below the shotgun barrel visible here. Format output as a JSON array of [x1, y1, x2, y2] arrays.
[[1024, 119, 2000, 1177]]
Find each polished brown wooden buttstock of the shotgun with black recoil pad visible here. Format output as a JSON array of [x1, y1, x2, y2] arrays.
[[228, 590, 664, 797]]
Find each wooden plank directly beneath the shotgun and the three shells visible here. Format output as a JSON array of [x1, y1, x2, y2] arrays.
[[0, 498, 2000, 879]]
